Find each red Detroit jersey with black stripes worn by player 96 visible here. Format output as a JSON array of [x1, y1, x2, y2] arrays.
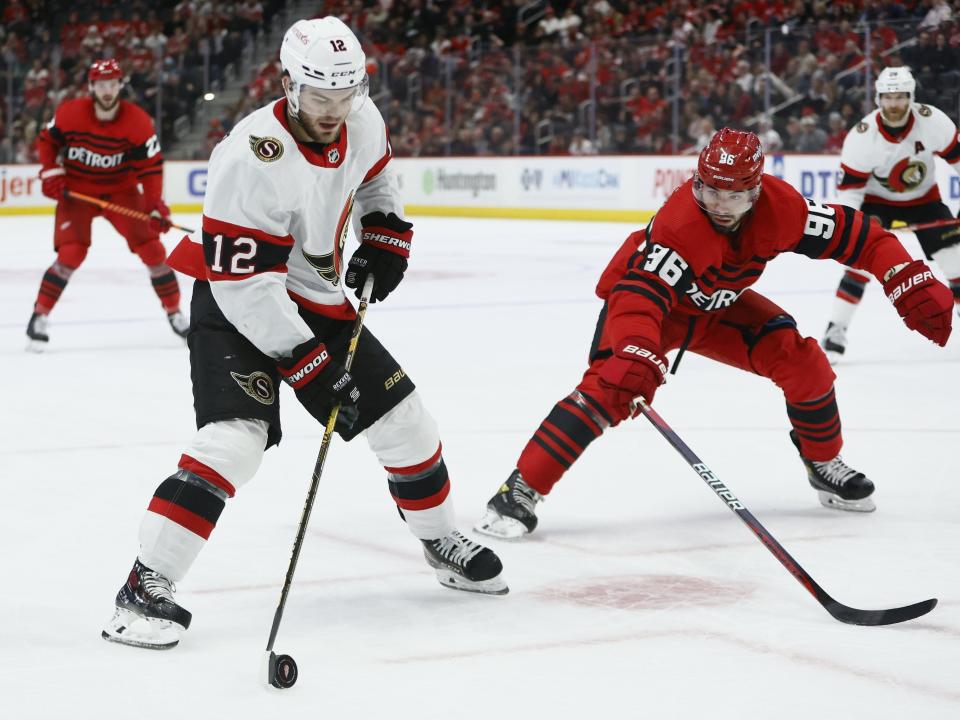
[[597, 175, 911, 352]]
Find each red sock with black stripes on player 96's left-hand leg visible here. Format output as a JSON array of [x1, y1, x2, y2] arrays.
[[517, 390, 612, 495]]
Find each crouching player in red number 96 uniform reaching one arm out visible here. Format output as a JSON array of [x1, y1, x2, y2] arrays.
[[476, 128, 952, 538]]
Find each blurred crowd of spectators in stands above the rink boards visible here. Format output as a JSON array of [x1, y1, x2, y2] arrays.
[[0, 0, 960, 161]]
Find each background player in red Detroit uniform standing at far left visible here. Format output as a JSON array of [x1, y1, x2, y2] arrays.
[[27, 60, 188, 352]]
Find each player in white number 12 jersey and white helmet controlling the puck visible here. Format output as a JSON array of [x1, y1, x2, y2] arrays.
[[103, 17, 507, 648]]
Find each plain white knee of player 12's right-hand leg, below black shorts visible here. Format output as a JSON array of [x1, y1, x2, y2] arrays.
[[366, 391, 440, 468]]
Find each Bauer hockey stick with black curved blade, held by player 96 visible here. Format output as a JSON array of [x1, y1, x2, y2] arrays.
[[636, 398, 937, 625]]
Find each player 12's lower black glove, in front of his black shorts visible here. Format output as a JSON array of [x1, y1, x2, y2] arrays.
[[277, 338, 360, 432]]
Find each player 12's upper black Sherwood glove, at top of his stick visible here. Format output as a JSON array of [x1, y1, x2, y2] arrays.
[[344, 212, 413, 302]]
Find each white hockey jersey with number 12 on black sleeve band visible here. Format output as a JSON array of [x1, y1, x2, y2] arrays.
[[168, 100, 403, 358]]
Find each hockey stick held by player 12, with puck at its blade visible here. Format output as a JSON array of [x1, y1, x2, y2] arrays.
[[265, 273, 373, 689]]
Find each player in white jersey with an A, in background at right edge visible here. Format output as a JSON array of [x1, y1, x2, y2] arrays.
[[821, 67, 960, 363]]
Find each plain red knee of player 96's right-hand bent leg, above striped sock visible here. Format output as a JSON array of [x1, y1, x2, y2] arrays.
[[750, 315, 836, 400]]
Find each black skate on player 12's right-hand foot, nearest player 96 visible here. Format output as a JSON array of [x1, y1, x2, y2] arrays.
[[422, 530, 509, 595]]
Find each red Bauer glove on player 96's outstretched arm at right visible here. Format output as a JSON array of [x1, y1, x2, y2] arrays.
[[883, 260, 953, 347]]
